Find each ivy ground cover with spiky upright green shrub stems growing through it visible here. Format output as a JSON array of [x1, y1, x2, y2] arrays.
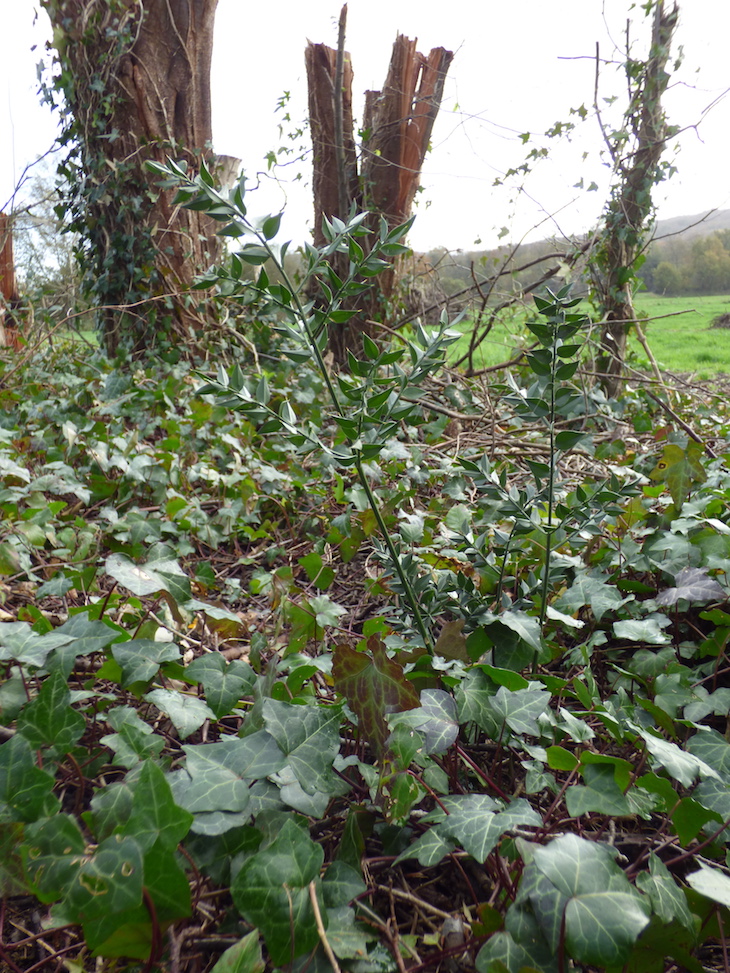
[[0, 166, 730, 973]]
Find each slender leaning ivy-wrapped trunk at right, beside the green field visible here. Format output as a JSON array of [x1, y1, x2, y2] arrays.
[[593, 0, 678, 397]]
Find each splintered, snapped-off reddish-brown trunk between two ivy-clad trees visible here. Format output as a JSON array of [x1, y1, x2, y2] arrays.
[[306, 19, 453, 367]]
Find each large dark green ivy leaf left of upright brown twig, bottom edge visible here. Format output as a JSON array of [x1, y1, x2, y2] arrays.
[[231, 820, 327, 966]]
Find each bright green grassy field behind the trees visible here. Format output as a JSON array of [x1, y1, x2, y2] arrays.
[[450, 294, 730, 378]]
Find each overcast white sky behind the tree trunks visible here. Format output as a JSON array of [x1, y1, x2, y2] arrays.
[[0, 0, 730, 249]]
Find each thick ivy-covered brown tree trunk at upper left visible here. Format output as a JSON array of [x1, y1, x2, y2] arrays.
[[42, 0, 219, 353]]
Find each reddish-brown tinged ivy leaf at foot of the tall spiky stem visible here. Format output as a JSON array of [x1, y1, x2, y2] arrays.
[[332, 635, 421, 757]]
